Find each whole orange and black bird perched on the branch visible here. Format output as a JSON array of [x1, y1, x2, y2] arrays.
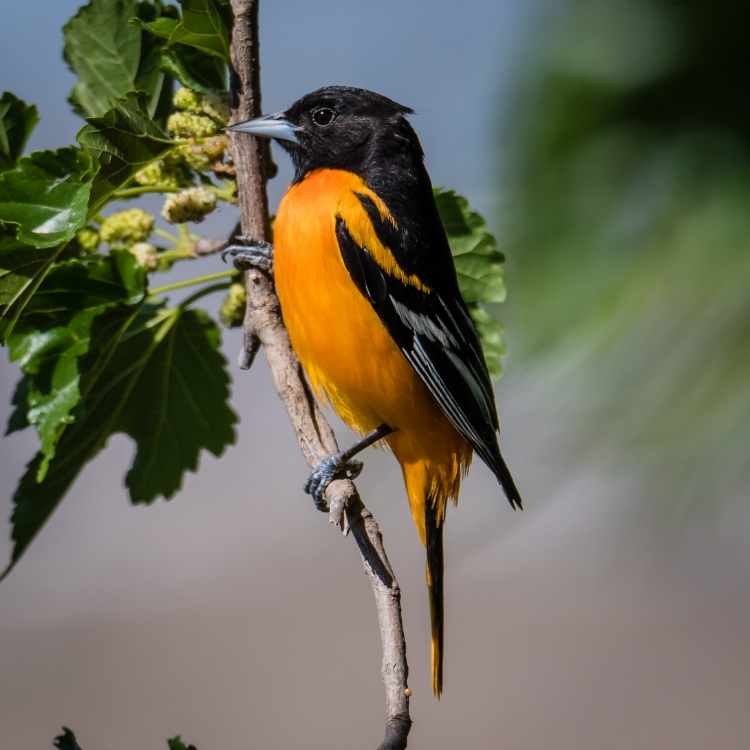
[[229, 86, 521, 696]]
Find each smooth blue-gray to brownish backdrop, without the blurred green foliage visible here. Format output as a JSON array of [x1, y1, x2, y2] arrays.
[[0, 0, 750, 750]]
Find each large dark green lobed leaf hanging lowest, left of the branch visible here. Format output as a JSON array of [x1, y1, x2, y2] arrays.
[[3, 305, 237, 576]]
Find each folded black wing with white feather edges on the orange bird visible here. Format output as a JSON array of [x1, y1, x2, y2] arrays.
[[336, 196, 521, 508]]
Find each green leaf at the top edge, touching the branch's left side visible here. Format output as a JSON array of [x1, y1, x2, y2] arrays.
[[143, 0, 229, 64]]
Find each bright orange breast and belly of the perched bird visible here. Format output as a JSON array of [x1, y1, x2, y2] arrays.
[[274, 170, 471, 541]]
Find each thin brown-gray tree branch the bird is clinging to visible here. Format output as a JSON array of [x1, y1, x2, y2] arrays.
[[231, 0, 411, 750]]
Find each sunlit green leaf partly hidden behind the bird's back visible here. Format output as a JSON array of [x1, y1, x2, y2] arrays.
[[434, 188, 505, 376]]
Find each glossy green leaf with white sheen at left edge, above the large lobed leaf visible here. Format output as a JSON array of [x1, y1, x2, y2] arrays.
[[0, 147, 95, 248]]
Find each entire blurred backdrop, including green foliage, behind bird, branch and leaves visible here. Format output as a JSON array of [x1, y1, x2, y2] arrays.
[[0, 0, 750, 750]]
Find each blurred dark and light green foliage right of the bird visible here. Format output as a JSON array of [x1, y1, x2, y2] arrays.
[[502, 0, 750, 508]]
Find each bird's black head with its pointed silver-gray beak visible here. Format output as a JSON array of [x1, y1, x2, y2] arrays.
[[230, 86, 422, 181]]
